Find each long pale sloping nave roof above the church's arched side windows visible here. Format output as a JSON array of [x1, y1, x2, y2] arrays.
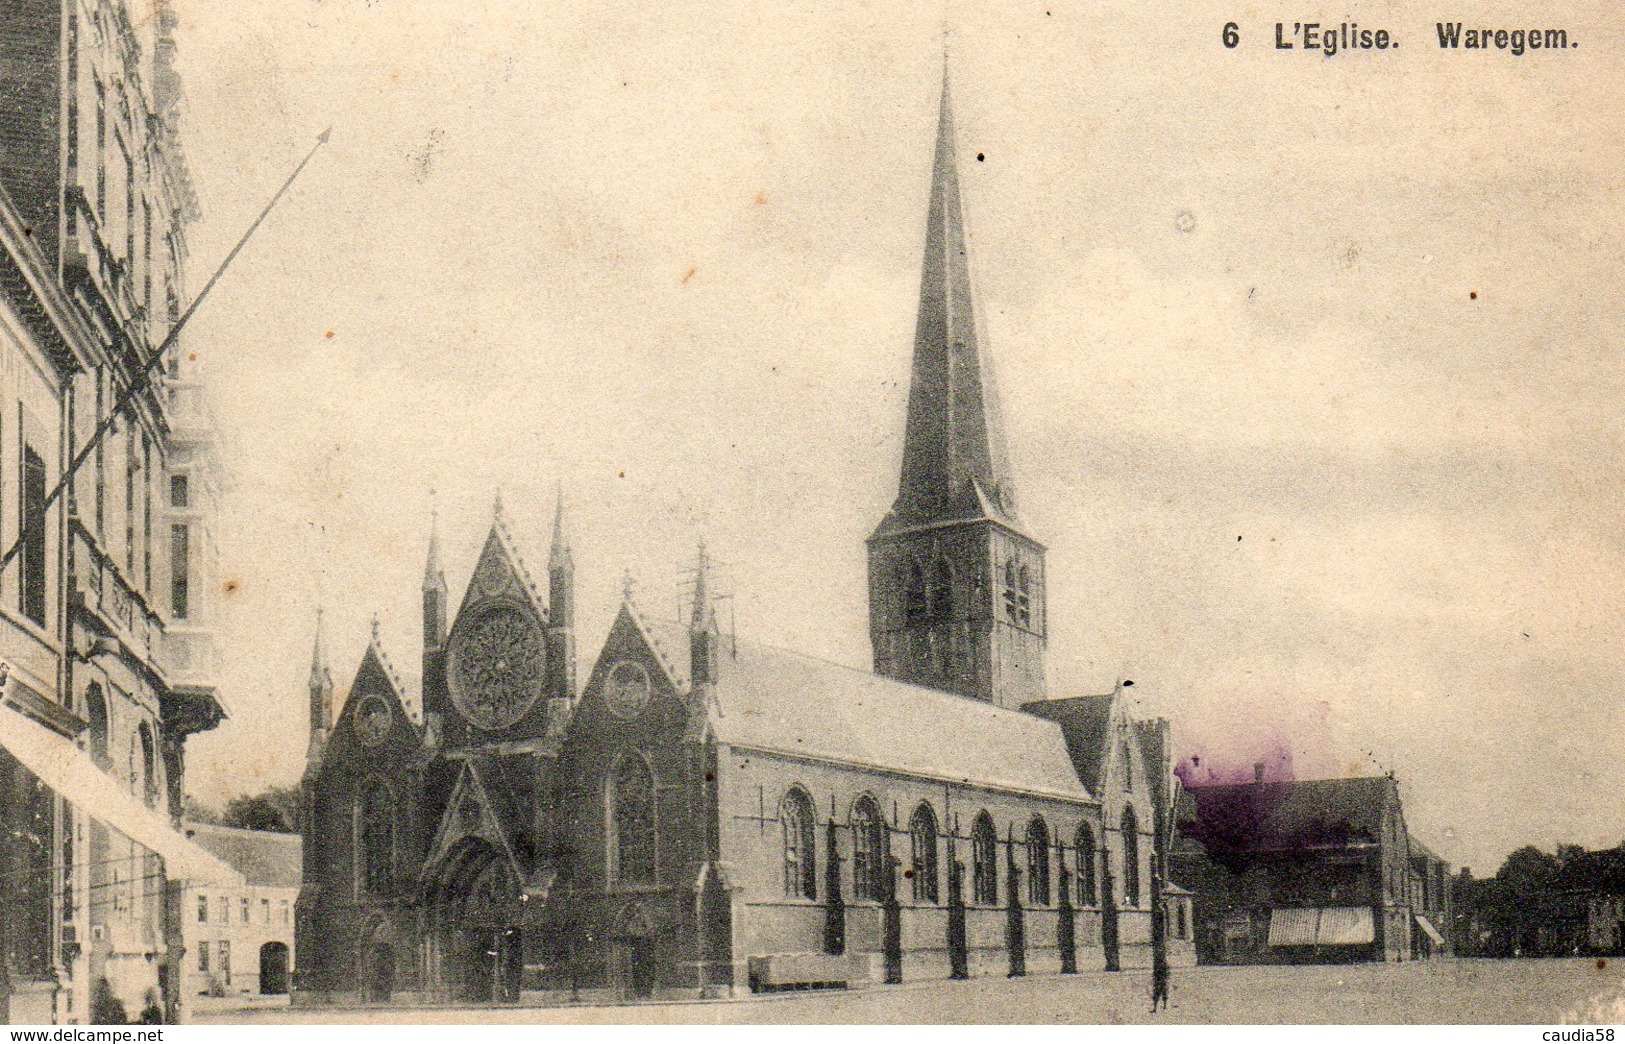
[[642, 621, 1094, 802]]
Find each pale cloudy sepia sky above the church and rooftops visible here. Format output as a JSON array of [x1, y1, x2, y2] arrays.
[[168, 0, 1625, 873]]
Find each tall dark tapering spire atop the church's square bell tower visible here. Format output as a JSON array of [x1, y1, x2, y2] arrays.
[[891, 69, 1014, 527]]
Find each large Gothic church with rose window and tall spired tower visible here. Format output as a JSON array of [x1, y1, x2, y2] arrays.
[[294, 75, 1191, 1005]]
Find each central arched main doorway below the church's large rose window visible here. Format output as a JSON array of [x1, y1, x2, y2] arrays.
[[431, 837, 525, 1003]]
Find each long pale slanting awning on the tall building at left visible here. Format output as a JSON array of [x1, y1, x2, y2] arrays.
[[0, 704, 242, 888]]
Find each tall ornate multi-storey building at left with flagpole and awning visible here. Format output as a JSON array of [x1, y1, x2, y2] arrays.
[[0, 0, 232, 1023]]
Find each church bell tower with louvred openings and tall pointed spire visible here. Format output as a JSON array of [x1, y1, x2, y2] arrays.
[[869, 70, 1047, 709]]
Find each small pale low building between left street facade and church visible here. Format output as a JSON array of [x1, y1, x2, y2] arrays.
[[180, 823, 302, 998]]
